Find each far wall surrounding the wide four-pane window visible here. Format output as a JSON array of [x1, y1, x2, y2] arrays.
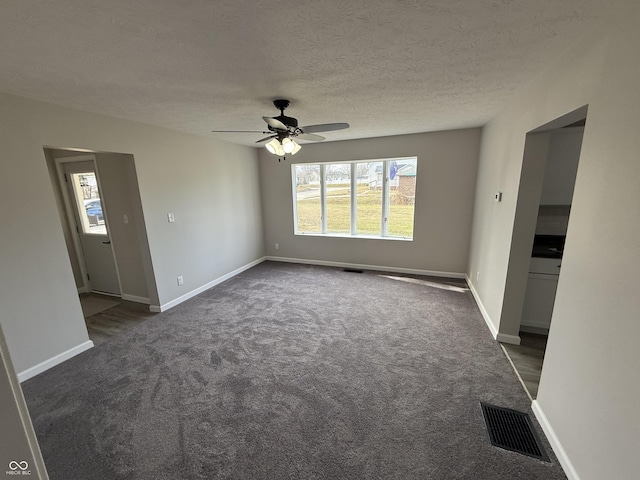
[[260, 129, 480, 273]]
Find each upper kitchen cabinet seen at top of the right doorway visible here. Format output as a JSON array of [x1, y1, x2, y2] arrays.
[[540, 127, 584, 205]]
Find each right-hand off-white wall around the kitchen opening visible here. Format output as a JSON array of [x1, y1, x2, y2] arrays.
[[468, 1, 640, 480]]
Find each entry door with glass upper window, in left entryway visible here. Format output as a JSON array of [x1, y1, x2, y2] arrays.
[[64, 161, 120, 295]]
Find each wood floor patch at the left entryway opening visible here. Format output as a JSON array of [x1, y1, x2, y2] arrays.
[[85, 294, 157, 345]]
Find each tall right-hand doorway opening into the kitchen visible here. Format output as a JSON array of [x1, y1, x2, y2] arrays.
[[503, 107, 587, 400]]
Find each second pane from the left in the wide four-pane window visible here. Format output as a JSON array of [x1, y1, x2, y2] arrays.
[[325, 163, 351, 234]]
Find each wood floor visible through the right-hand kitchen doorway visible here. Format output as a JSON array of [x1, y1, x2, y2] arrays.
[[502, 332, 547, 400]]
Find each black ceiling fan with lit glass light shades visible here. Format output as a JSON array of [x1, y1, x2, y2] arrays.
[[212, 99, 349, 157]]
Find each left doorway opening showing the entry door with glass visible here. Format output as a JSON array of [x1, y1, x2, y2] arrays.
[[43, 146, 158, 343]]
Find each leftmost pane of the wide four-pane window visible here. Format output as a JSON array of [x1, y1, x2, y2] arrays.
[[293, 165, 322, 233]]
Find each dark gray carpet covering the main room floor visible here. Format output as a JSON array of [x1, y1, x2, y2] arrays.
[[23, 262, 566, 480]]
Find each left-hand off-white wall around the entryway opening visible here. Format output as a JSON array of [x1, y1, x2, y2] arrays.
[[0, 94, 263, 372]]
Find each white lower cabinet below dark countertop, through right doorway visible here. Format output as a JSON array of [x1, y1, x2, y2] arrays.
[[520, 257, 561, 330]]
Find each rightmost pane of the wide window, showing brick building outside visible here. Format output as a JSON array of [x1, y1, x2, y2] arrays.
[[387, 158, 418, 238]]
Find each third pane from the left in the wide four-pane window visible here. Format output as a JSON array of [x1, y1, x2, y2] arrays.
[[356, 162, 383, 235]]
